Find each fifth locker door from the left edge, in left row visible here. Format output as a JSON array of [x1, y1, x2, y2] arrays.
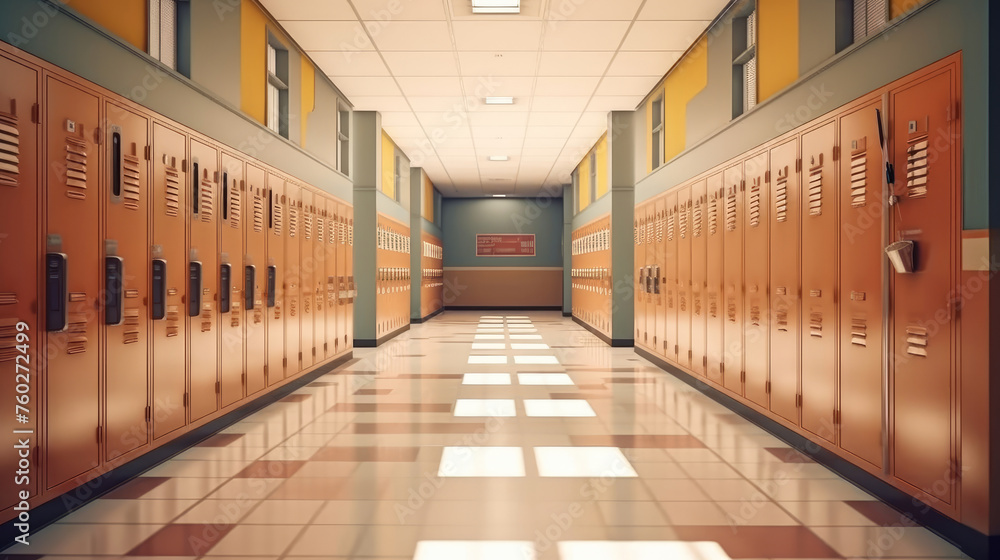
[[187, 139, 225, 422]]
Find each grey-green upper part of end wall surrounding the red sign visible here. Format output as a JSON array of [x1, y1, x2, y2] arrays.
[[441, 198, 564, 267]]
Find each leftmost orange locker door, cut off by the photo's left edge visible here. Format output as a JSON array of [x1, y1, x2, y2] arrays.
[[0, 56, 43, 510]]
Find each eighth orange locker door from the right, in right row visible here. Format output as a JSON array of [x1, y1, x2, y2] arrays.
[[691, 181, 708, 375]]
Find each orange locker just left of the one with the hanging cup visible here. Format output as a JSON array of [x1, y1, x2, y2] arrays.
[[838, 98, 885, 468]]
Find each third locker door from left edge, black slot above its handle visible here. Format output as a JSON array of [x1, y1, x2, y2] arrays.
[[101, 103, 150, 461]]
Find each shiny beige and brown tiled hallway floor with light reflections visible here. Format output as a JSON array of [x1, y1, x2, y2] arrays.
[[8, 312, 963, 560]]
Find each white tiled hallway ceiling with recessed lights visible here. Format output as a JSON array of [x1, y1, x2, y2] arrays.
[[261, 0, 728, 197]]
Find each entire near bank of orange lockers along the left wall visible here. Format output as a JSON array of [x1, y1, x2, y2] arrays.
[[0, 48, 353, 518]]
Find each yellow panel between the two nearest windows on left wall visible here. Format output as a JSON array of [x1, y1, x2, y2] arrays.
[[240, 1, 267, 124]]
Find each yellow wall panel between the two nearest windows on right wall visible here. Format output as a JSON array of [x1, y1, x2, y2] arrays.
[[757, 0, 799, 101]]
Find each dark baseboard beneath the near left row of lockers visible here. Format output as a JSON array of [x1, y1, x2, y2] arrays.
[[0, 352, 354, 558]]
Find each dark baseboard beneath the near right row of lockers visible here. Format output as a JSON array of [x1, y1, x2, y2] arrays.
[[635, 346, 1000, 560]]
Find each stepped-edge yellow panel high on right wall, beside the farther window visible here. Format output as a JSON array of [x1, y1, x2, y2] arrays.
[[664, 37, 708, 161]]
